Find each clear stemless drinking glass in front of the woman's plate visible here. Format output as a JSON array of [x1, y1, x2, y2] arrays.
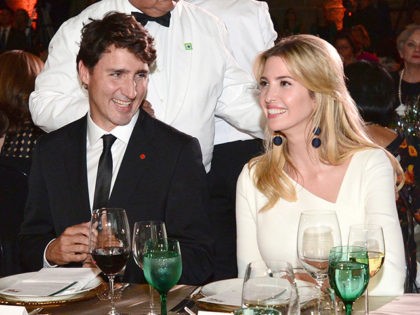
[[242, 260, 299, 315]]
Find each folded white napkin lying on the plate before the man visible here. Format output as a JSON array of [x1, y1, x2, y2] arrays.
[[0, 268, 100, 296]]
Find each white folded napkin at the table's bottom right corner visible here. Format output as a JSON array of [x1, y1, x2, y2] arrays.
[[369, 294, 420, 315]]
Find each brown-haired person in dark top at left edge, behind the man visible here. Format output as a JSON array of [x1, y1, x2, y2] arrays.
[[0, 50, 44, 277]]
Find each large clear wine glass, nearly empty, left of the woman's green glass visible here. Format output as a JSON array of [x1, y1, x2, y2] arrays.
[[297, 210, 341, 312]]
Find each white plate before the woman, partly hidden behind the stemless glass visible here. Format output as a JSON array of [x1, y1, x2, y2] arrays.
[[201, 278, 319, 306]]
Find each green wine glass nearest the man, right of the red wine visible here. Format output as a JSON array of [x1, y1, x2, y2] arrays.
[[143, 238, 182, 315]]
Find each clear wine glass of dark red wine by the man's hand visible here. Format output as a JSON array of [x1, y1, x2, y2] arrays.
[[89, 208, 131, 315]]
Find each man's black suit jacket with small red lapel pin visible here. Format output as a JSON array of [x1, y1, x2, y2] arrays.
[[19, 111, 213, 284]]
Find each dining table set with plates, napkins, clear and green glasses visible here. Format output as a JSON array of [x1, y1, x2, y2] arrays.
[[0, 208, 420, 315]]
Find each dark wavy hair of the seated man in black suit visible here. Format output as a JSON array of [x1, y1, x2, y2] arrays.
[[76, 12, 156, 69]]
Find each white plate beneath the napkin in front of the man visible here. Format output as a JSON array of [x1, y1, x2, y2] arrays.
[[0, 272, 102, 304]]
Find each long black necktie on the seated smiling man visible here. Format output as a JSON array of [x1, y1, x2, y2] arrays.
[[93, 134, 117, 210]]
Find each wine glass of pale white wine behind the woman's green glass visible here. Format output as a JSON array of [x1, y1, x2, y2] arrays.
[[348, 224, 385, 314]]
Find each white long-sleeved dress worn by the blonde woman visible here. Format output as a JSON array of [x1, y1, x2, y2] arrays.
[[236, 149, 406, 295]]
